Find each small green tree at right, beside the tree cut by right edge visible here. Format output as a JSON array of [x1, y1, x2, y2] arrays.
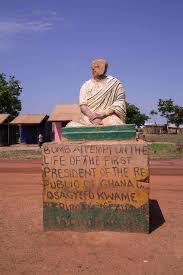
[[158, 98, 175, 124]]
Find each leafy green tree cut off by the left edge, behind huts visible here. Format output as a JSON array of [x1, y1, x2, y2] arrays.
[[0, 73, 22, 117]]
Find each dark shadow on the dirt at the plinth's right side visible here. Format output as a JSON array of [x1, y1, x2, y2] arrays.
[[149, 200, 165, 233]]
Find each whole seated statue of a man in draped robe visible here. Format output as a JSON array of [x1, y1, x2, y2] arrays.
[[67, 59, 126, 127]]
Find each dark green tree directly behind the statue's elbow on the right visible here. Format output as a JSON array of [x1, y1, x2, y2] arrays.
[[126, 103, 149, 126]]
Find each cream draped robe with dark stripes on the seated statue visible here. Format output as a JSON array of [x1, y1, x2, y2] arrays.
[[67, 76, 126, 127]]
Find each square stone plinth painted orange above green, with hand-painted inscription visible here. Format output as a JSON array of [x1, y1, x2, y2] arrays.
[[42, 141, 149, 233]]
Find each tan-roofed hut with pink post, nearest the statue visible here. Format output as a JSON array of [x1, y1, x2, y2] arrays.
[[48, 104, 81, 142]]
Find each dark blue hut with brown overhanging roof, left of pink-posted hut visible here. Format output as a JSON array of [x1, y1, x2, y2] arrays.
[[11, 114, 52, 144]]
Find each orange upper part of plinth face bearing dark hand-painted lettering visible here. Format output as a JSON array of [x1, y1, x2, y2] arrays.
[[42, 143, 149, 209]]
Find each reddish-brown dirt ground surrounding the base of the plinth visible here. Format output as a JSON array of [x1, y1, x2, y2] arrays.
[[0, 160, 183, 275]]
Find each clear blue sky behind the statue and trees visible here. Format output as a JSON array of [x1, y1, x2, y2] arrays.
[[0, 0, 183, 121]]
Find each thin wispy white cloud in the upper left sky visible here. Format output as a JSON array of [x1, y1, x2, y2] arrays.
[[0, 10, 64, 55]]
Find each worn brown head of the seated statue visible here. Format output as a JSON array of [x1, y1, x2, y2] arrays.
[[91, 59, 108, 78]]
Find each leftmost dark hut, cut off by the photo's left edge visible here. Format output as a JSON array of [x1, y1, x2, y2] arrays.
[[0, 114, 17, 146]]
